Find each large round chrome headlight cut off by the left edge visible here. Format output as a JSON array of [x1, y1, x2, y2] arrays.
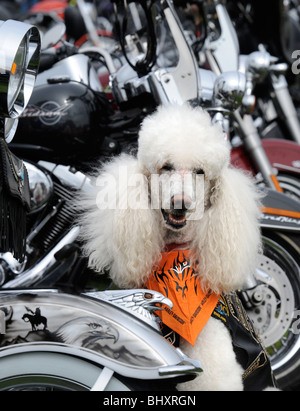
[[0, 20, 41, 118]]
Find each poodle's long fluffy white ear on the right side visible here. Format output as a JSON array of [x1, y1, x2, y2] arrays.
[[194, 168, 261, 292]]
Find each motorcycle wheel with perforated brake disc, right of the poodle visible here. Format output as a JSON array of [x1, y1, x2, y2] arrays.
[[243, 235, 300, 389]]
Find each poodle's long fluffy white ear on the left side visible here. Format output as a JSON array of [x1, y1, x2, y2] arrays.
[[80, 155, 162, 288]]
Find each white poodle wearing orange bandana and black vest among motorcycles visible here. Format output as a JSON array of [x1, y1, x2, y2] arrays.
[[81, 105, 276, 390]]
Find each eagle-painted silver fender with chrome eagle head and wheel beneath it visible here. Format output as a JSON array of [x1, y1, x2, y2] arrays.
[[0, 289, 202, 391]]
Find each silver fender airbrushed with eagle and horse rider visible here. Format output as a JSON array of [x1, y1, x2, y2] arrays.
[[0, 290, 201, 380]]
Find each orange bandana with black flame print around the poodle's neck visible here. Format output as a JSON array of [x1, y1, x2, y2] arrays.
[[146, 250, 220, 345]]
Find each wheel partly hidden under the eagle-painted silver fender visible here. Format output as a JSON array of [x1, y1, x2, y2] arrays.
[[0, 348, 136, 391]]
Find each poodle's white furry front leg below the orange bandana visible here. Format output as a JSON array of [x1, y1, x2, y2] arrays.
[[177, 318, 244, 391]]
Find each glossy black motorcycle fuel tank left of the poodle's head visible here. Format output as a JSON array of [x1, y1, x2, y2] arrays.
[[13, 78, 111, 161]]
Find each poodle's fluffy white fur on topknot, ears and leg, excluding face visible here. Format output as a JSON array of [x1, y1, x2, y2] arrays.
[[80, 105, 261, 389]]
